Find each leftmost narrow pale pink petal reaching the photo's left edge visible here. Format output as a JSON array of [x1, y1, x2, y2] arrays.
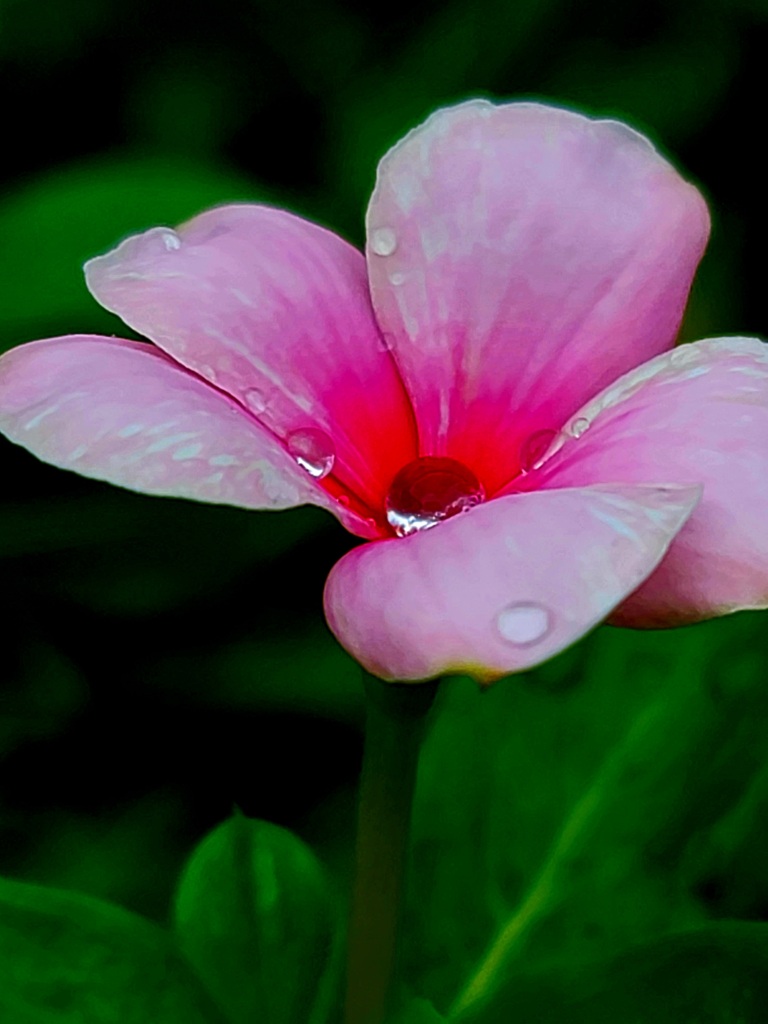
[[0, 335, 374, 532]]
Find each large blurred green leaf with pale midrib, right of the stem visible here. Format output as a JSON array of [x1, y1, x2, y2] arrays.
[[408, 615, 768, 1007]]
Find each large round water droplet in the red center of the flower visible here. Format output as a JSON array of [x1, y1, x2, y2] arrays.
[[386, 456, 485, 537]]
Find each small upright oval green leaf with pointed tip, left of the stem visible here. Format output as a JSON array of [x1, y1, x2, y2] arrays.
[[175, 814, 344, 1024]]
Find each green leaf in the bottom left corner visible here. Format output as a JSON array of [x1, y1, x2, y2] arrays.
[[0, 879, 221, 1024]]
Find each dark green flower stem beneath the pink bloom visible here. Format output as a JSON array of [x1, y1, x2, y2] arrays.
[[344, 677, 437, 1024]]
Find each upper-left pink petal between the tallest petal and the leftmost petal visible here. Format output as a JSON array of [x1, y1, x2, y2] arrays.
[[86, 205, 415, 520]]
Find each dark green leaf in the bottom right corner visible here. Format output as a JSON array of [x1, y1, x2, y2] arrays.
[[452, 922, 768, 1024]]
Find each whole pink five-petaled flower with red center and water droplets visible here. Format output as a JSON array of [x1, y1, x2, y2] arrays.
[[0, 100, 768, 681]]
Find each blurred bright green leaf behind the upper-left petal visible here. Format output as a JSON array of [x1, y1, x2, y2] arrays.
[[0, 154, 263, 349]]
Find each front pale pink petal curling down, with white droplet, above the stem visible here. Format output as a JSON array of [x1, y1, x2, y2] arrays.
[[325, 485, 700, 682]]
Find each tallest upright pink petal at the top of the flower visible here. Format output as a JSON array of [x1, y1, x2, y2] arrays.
[[368, 100, 709, 494]]
